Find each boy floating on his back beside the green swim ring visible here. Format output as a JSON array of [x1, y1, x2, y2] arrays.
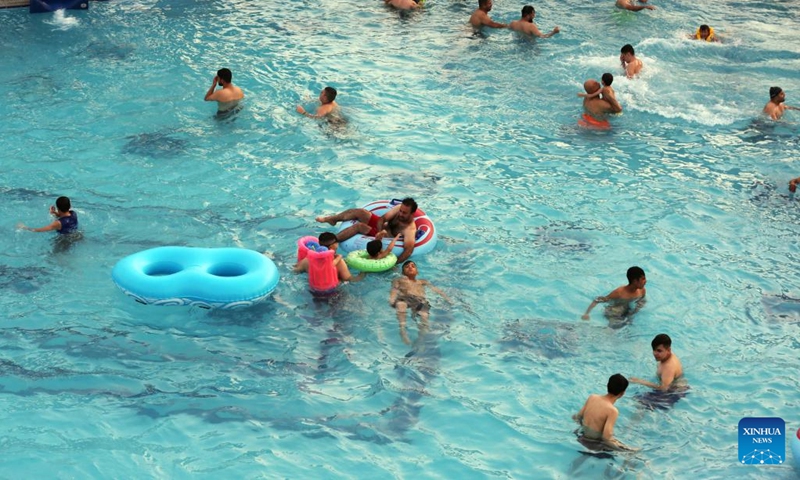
[[389, 260, 453, 345]]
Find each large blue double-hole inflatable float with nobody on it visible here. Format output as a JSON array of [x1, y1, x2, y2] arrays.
[[111, 247, 280, 308]]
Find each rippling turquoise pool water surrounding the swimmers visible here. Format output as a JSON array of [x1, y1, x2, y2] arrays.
[[0, 0, 800, 478]]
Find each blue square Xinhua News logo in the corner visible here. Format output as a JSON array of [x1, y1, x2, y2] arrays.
[[739, 417, 786, 465]]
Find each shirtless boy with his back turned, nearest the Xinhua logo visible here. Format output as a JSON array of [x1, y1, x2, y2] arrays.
[[572, 373, 636, 450]]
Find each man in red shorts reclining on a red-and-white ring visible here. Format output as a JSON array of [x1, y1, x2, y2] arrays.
[[316, 197, 417, 263]]
